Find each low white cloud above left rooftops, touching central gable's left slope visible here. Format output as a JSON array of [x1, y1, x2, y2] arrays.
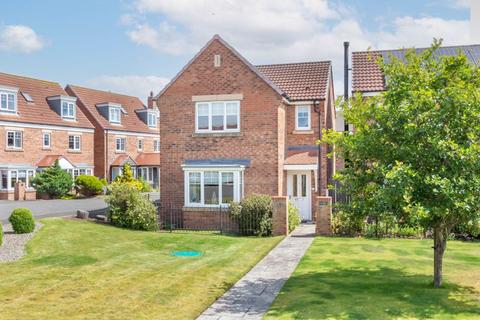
[[87, 75, 170, 102]]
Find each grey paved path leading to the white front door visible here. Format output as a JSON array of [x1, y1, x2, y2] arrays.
[[197, 224, 315, 320]]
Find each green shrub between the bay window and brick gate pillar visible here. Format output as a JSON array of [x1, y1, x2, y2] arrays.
[[230, 194, 272, 236]]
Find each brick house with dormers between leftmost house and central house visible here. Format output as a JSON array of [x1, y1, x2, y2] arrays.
[[65, 85, 160, 188]]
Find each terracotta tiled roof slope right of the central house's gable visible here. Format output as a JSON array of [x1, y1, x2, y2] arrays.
[[256, 61, 331, 101]]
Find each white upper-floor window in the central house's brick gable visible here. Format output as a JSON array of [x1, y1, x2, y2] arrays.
[[195, 101, 240, 133]]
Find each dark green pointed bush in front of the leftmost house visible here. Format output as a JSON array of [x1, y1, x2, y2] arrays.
[[32, 160, 73, 199]]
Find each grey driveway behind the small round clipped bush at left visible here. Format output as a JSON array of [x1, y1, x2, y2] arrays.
[[0, 192, 160, 224]]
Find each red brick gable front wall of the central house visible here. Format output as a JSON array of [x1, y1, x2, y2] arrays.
[[157, 40, 281, 205]]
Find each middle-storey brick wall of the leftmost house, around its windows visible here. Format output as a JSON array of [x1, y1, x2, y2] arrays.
[[0, 126, 94, 166]]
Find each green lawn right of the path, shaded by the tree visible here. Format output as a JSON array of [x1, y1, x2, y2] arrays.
[[266, 238, 480, 320]]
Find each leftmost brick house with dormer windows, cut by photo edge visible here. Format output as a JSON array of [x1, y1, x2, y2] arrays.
[[0, 73, 94, 200]]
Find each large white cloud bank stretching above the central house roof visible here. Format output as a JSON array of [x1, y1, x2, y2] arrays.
[[127, 0, 470, 93]]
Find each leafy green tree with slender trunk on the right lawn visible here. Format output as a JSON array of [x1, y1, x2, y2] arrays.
[[325, 40, 480, 287]]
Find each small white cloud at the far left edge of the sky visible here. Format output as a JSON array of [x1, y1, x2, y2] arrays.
[[0, 25, 45, 53]]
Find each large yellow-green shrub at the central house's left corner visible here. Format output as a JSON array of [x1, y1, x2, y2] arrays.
[[105, 183, 157, 231]]
